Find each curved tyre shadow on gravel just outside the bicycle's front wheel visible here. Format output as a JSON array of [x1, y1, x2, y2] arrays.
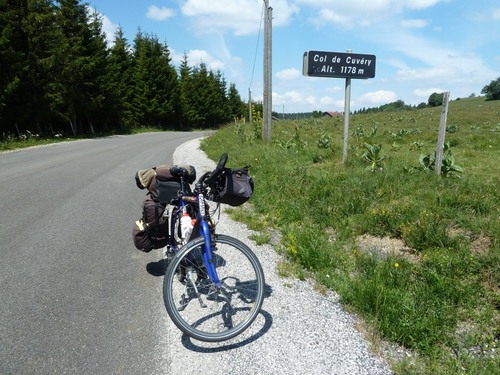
[[181, 284, 273, 353]]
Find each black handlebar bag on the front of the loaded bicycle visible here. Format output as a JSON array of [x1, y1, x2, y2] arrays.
[[211, 165, 254, 207]]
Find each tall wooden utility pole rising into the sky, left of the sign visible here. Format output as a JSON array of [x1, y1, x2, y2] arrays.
[[262, 0, 273, 141]]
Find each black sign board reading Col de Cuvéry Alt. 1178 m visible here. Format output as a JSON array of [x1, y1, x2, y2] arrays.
[[302, 51, 376, 79]]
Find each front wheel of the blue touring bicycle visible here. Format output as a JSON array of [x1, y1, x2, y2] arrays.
[[163, 235, 265, 342]]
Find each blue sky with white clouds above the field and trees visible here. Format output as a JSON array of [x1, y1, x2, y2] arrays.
[[87, 0, 500, 113]]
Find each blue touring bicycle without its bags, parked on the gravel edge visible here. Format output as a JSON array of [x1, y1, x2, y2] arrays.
[[163, 154, 265, 342]]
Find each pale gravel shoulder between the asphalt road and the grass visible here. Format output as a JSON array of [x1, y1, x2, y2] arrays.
[[164, 139, 391, 375]]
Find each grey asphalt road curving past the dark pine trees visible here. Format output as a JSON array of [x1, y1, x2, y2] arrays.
[[0, 132, 207, 375]]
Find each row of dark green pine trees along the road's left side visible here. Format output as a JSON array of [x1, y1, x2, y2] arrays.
[[0, 0, 247, 136]]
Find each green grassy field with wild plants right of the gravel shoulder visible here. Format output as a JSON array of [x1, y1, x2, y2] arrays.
[[202, 98, 500, 374]]
